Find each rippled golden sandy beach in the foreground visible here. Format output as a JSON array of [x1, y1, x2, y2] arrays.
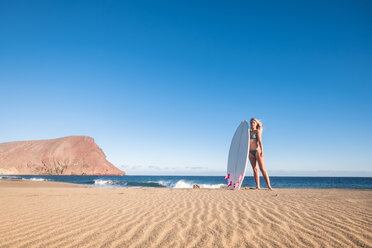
[[0, 180, 372, 247]]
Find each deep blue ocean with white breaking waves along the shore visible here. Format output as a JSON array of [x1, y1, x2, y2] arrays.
[[0, 175, 372, 189]]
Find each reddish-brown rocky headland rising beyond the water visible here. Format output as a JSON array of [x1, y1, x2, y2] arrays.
[[0, 136, 125, 175]]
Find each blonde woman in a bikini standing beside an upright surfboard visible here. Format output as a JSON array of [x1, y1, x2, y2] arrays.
[[249, 118, 272, 189]]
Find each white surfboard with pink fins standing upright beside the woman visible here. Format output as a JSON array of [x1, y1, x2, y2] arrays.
[[225, 120, 249, 189]]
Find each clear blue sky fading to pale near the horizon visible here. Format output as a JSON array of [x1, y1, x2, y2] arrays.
[[0, 0, 372, 176]]
